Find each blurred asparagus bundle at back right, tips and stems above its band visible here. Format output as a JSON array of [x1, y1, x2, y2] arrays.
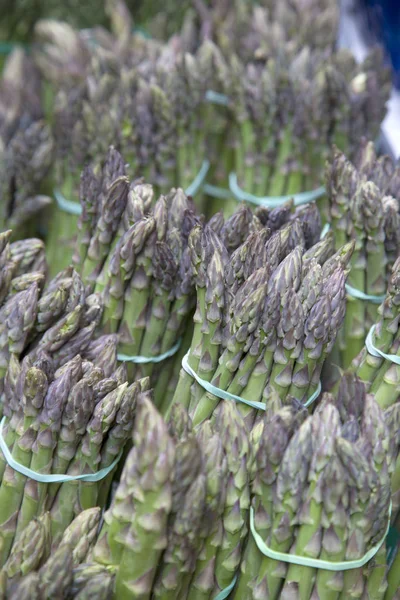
[[225, 42, 390, 197]]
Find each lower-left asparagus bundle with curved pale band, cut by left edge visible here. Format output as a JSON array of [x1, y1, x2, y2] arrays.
[[0, 338, 141, 564]]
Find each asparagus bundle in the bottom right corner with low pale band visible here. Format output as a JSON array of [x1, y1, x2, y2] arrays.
[[233, 376, 395, 600]]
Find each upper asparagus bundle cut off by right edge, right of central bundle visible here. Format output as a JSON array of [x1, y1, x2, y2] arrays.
[[326, 142, 400, 367]]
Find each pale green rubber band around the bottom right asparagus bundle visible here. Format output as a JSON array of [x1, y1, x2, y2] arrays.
[[250, 502, 392, 572]]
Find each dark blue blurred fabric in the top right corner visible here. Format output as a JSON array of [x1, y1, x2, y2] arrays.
[[361, 0, 400, 88]]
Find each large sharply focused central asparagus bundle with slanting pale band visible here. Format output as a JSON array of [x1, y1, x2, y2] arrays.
[[173, 207, 353, 425]]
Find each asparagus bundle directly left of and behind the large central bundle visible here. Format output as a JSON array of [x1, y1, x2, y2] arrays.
[[52, 148, 200, 392]]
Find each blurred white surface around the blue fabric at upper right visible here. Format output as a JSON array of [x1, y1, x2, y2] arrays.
[[338, 0, 400, 158]]
